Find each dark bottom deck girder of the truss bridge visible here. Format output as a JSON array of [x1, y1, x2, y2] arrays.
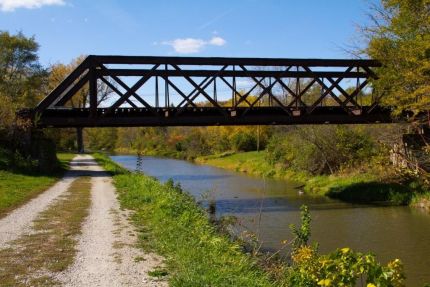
[[22, 107, 393, 127]]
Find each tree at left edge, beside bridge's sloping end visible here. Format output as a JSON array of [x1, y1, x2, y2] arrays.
[[0, 31, 47, 151]]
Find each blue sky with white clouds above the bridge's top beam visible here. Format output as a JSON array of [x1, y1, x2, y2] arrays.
[[0, 0, 376, 66]]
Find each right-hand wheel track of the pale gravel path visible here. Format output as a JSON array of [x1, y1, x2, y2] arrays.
[[58, 158, 167, 286]]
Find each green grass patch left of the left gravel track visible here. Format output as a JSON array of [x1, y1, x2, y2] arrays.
[[0, 153, 74, 218]]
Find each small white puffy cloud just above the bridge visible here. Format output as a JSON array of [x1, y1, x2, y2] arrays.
[[162, 36, 227, 54]]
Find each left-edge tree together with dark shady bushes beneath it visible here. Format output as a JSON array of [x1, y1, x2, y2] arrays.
[[0, 31, 57, 170]]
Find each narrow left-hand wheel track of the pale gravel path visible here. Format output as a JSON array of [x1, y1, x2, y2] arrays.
[[0, 155, 91, 248]]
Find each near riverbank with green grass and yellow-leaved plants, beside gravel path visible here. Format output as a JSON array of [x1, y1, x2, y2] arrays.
[[95, 155, 403, 286]]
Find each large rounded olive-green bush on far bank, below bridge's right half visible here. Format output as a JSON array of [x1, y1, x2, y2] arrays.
[[267, 126, 377, 174]]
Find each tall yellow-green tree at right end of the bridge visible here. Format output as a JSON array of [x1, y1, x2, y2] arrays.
[[363, 0, 430, 118]]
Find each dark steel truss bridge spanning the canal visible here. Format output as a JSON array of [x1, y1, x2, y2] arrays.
[[20, 55, 392, 127]]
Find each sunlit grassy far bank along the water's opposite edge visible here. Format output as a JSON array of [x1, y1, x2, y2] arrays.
[[195, 151, 430, 208]]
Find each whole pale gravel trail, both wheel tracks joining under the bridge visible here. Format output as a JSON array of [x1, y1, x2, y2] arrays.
[[0, 155, 167, 286]]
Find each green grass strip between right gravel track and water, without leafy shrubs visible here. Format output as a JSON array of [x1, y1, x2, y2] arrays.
[[95, 154, 279, 286]]
